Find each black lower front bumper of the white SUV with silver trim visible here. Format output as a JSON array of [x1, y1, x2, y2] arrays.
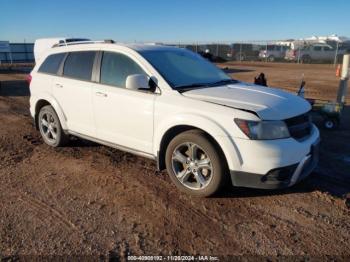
[[230, 139, 320, 189]]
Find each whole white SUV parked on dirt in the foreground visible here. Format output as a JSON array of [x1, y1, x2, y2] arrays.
[[30, 42, 319, 196]]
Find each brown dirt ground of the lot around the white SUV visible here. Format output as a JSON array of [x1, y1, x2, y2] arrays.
[[0, 63, 350, 260]]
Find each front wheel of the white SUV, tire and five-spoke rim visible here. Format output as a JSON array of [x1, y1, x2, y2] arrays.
[[165, 130, 228, 197]]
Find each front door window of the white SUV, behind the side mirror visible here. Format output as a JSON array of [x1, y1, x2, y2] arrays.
[[100, 52, 145, 87]]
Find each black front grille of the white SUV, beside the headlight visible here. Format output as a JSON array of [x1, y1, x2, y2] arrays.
[[284, 112, 311, 140]]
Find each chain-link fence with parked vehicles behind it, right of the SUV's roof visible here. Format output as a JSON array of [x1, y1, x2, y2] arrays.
[[155, 40, 350, 65]]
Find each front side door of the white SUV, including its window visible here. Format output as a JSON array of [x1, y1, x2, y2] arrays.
[[93, 52, 156, 154]]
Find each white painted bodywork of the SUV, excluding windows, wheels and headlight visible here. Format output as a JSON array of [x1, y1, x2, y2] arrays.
[[30, 43, 319, 190]]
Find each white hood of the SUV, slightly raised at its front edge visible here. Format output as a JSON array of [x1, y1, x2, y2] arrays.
[[182, 82, 311, 120]]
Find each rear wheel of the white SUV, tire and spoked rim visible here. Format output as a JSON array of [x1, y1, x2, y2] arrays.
[[38, 105, 69, 147]]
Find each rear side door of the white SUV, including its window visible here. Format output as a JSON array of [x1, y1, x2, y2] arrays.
[[53, 51, 97, 136]]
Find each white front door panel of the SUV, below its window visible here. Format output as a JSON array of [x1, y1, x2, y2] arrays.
[[92, 84, 156, 153]]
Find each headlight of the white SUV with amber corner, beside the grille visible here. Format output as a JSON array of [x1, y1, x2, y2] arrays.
[[235, 118, 290, 140]]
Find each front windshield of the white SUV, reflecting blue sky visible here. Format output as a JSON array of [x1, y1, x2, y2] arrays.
[[140, 48, 231, 90]]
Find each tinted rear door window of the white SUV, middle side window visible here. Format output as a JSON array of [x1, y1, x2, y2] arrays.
[[63, 51, 96, 80]]
